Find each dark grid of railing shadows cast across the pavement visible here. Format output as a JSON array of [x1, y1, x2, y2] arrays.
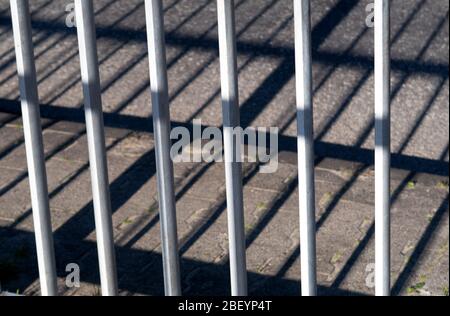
[[0, 0, 448, 295]]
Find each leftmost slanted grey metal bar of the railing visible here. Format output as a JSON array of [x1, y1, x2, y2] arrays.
[[10, 0, 57, 296]]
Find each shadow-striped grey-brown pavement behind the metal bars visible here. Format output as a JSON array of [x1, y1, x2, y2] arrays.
[[0, 0, 449, 295]]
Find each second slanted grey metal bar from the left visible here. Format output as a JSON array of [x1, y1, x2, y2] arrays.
[[75, 0, 118, 296]]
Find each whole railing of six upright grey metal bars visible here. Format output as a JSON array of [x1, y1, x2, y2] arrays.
[[10, 0, 390, 296]]
